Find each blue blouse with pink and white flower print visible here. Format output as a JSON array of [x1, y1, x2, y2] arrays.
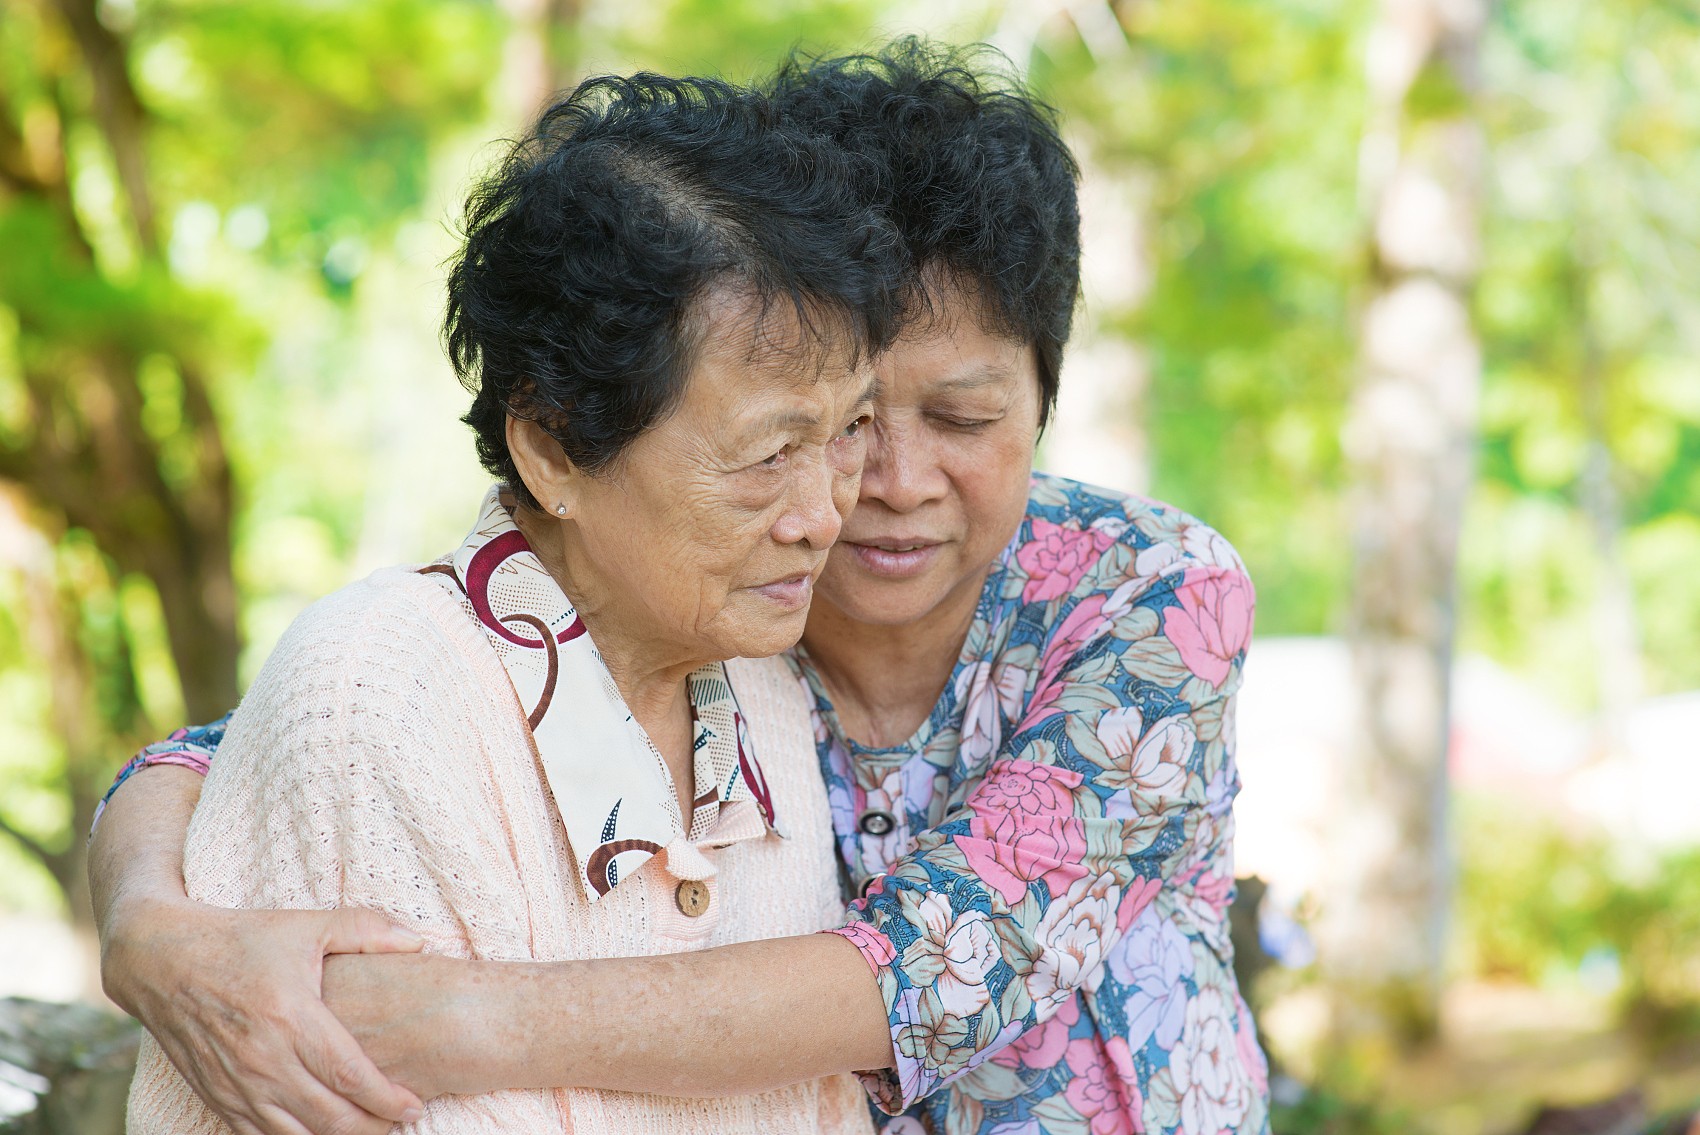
[[93, 474, 1268, 1135]]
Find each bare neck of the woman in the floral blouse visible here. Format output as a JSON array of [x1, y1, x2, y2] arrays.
[[802, 566, 991, 748]]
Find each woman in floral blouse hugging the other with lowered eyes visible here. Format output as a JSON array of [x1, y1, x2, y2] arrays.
[[95, 44, 1268, 1135]]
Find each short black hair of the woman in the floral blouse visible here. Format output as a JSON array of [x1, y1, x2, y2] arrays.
[[767, 36, 1080, 425]]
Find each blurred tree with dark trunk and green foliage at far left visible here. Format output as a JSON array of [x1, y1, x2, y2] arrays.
[[0, 0, 496, 944]]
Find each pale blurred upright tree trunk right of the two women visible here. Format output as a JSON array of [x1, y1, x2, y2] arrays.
[[1319, 0, 1484, 1040]]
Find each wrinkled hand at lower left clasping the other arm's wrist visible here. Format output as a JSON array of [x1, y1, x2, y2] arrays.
[[100, 899, 422, 1135]]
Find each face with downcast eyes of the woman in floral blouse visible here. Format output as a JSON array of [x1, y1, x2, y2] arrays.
[[816, 289, 1039, 625]]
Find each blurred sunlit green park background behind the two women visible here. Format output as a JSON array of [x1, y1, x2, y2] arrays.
[[0, 0, 1700, 1135]]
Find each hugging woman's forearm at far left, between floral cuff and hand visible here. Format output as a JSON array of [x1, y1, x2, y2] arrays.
[[88, 765, 202, 1013]]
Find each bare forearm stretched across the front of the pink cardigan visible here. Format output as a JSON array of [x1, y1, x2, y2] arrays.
[[325, 935, 893, 1096]]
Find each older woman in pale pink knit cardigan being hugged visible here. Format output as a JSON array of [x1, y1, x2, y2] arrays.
[[119, 75, 901, 1135]]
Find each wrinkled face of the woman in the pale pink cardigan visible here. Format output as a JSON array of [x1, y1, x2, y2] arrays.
[[523, 294, 874, 664]]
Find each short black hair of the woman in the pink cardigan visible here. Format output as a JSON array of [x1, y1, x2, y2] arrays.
[[444, 73, 908, 506]]
